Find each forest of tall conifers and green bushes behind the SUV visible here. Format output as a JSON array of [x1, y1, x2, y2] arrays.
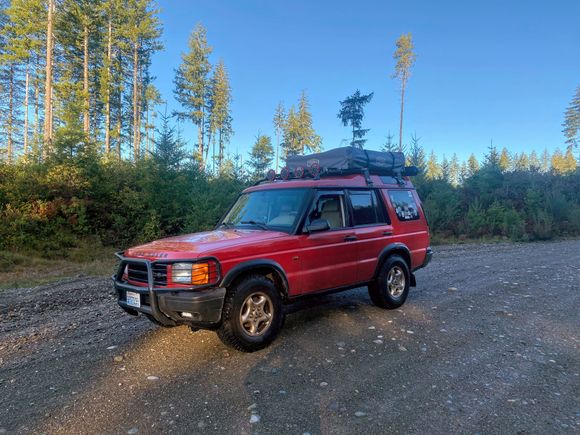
[[0, 0, 580, 257]]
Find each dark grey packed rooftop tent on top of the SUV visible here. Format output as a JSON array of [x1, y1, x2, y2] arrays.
[[287, 146, 405, 175]]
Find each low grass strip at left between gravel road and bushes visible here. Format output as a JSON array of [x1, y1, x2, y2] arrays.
[[0, 245, 116, 289]]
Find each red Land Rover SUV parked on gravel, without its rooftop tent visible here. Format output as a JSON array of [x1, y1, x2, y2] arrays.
[[113, 148, 432, 351]]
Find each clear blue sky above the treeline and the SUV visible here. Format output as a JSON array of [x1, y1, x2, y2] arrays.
[[152, 0, 580, 162]]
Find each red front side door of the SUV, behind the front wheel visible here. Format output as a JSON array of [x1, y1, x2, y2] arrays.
[[297, 190, 357, 294]]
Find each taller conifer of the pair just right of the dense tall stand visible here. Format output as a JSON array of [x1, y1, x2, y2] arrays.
[[174, 24, 212, 166]]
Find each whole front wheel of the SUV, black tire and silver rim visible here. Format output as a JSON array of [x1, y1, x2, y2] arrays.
[[217, 275, 284, 352]]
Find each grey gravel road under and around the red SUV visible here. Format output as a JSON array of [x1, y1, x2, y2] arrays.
[[0, 240, 580, 434]]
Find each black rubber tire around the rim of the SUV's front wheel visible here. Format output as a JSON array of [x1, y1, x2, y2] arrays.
[[216, 275, 284, 352]]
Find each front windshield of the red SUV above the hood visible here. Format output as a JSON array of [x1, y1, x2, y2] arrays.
[[221, 189, 308, 232]]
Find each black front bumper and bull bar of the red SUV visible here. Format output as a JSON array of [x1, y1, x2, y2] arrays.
[[112, 253, 226, 329]]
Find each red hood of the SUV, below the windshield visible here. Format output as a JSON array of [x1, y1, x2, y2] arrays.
[[125, 229, 287, 260]]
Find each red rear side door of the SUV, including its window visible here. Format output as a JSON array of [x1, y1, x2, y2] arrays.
[[348, 189, 393, 282]]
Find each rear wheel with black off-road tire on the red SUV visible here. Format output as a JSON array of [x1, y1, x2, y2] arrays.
[[369, 255, 411, 310]]
